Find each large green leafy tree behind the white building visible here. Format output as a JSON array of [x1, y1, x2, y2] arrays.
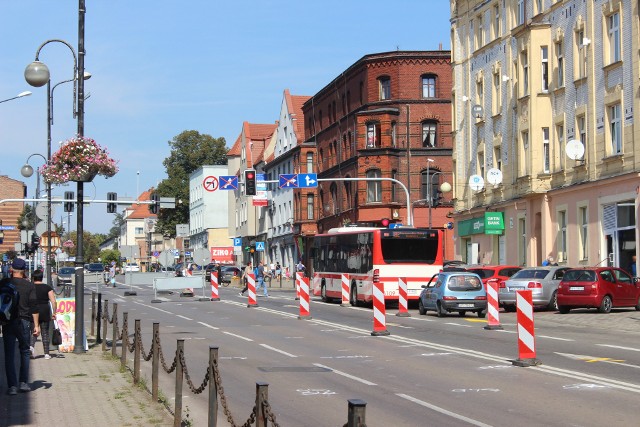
[[156, 130, 227, 237]]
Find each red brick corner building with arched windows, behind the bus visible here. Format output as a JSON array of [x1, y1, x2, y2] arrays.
[[302, 50, 453, 258]]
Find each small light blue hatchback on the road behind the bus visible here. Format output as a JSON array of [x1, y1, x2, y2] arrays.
[[418, 271, 487, 318]]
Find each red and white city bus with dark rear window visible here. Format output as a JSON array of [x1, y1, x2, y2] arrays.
[[311, 227, 444, 305]]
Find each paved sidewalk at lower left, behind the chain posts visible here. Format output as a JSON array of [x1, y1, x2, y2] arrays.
[[0, 340, 173, 427]]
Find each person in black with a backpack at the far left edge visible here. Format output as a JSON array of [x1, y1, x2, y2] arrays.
[[0, 258, 40, 396]]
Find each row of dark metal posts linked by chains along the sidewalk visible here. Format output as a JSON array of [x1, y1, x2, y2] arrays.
[[91, 292, 366, 427]]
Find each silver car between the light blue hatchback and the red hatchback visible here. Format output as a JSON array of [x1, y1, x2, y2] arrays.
[[498, 267, 569, 311]]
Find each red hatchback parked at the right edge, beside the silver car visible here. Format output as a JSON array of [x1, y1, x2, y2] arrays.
[[558, 267, 640, 314]]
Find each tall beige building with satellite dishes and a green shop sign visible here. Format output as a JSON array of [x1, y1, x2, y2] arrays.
[[451, 0, 640, 269]]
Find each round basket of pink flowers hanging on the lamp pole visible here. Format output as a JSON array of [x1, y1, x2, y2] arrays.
[[40, 136, 118, 184]]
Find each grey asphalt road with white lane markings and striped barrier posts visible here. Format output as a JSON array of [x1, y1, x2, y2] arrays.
[[87, 278, 640, 426]]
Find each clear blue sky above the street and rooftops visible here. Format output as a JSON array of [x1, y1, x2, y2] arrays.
[[0, 0, 450, 233]]
